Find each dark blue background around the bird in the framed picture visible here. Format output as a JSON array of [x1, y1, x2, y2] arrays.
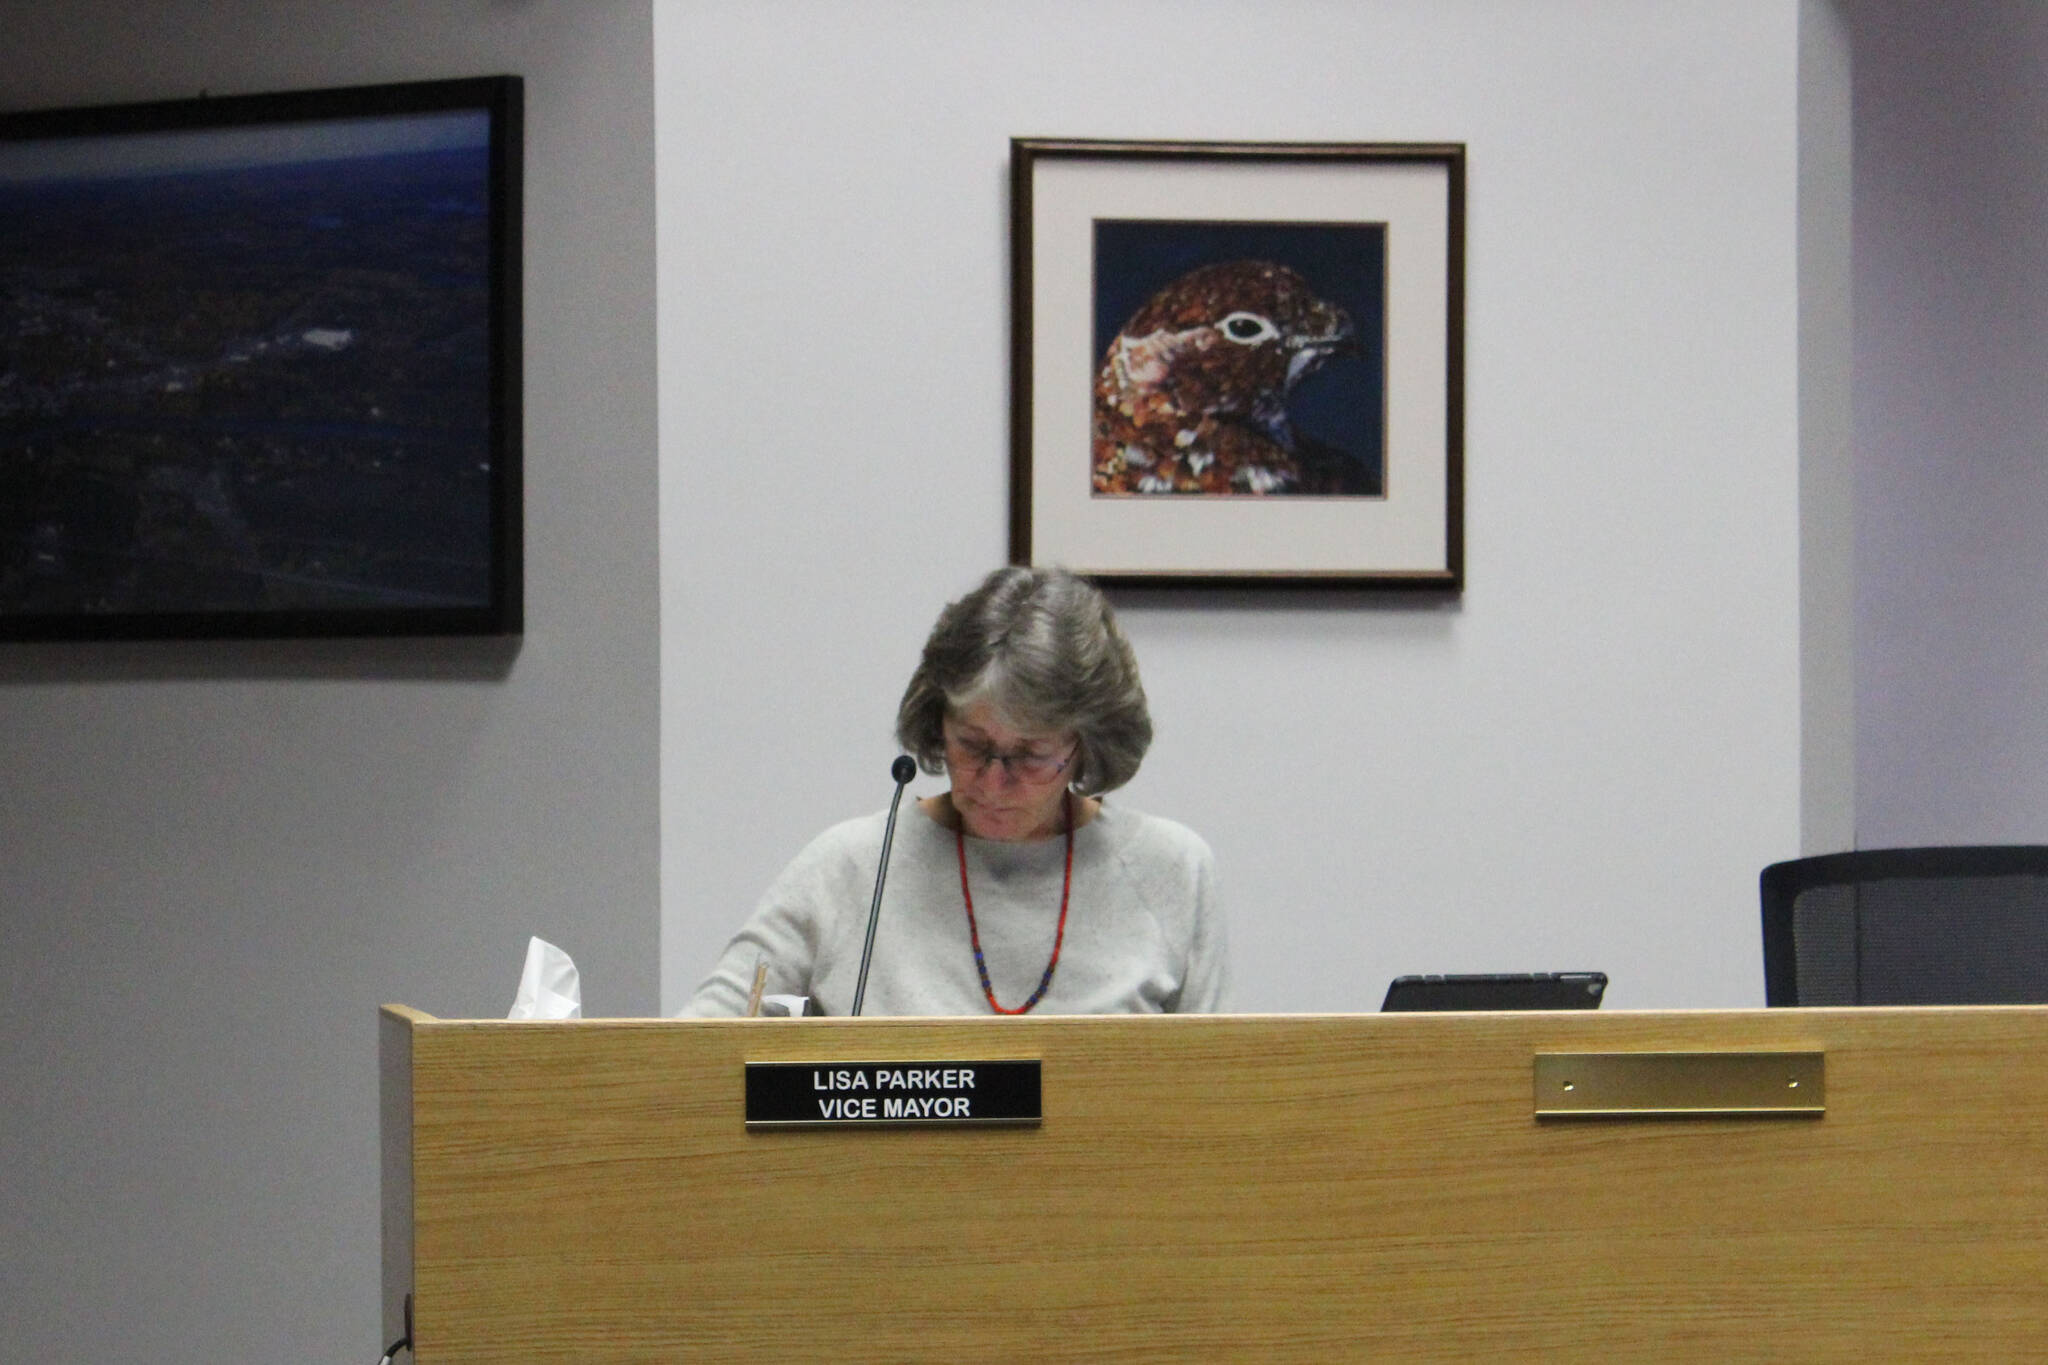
[[1087, 219, 1386, 493]]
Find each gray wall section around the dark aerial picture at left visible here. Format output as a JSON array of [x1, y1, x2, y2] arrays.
[[0, 0, 657, 1363]]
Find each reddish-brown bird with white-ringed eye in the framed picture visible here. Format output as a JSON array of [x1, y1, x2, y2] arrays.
[[1094, 260, 1372, 493]]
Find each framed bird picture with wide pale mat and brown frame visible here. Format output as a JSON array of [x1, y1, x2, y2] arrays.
[[1010, 137, 1464, 591]]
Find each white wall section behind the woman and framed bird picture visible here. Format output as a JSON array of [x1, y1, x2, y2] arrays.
[[655, 0, 1847, 1009]]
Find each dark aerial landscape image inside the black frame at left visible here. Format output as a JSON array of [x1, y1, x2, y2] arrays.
[[0, 111, 492, 616]]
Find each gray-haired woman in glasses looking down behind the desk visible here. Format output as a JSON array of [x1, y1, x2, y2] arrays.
[[682, 569, 1223, 1015]]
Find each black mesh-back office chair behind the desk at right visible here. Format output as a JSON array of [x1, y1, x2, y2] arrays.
[[1761, 845, 2048, 1005]]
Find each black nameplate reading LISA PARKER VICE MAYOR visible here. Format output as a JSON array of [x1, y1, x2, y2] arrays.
[[748, 1062, 1042, 1128]]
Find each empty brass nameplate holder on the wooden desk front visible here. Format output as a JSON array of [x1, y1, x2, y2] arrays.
[[1536, 1052, 1827, 1119]]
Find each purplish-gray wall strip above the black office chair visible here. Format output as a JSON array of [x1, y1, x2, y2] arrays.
[[1849, 0, 2048, 847]]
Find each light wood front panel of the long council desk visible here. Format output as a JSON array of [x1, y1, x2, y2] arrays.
[[387, 1007, 2048, 1365]]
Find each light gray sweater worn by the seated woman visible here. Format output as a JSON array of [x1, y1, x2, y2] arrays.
[[682, 802, 1225, 1015]]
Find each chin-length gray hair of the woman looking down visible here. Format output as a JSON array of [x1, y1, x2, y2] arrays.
[[897, 567, 1151, 796]]
